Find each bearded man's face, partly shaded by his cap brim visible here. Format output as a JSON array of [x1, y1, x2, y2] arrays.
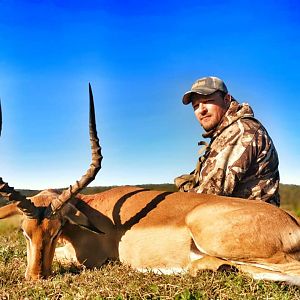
[[191, 92, 230, 131]]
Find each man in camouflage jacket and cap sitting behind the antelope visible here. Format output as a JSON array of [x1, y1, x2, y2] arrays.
[[175, 77, 280, 206]]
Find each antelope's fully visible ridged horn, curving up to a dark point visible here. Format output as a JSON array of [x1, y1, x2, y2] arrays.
[[50, 84, 102, 214]]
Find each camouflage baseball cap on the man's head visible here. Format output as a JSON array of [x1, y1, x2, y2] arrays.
[[182, 76, 228, 104]]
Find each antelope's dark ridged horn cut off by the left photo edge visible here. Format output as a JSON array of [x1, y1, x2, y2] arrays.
[[0, 102, 38, 217]]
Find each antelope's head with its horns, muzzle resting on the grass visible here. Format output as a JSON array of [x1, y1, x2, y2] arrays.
[[0, 85, 102, 280]]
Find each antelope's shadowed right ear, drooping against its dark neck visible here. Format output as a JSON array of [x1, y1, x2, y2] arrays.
[[61, 203, 104, 234]]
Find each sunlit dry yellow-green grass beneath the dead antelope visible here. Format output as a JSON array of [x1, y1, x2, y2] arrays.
[[0, 218, 300, 300]]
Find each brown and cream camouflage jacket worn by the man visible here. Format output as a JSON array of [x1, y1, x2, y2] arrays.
[[175, 100, 280, 206]]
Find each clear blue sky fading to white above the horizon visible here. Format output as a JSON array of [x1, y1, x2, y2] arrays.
[[0, 0, 300, 189]]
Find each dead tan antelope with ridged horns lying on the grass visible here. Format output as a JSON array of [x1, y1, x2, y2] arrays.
[[0, 85, 300, 285]]
